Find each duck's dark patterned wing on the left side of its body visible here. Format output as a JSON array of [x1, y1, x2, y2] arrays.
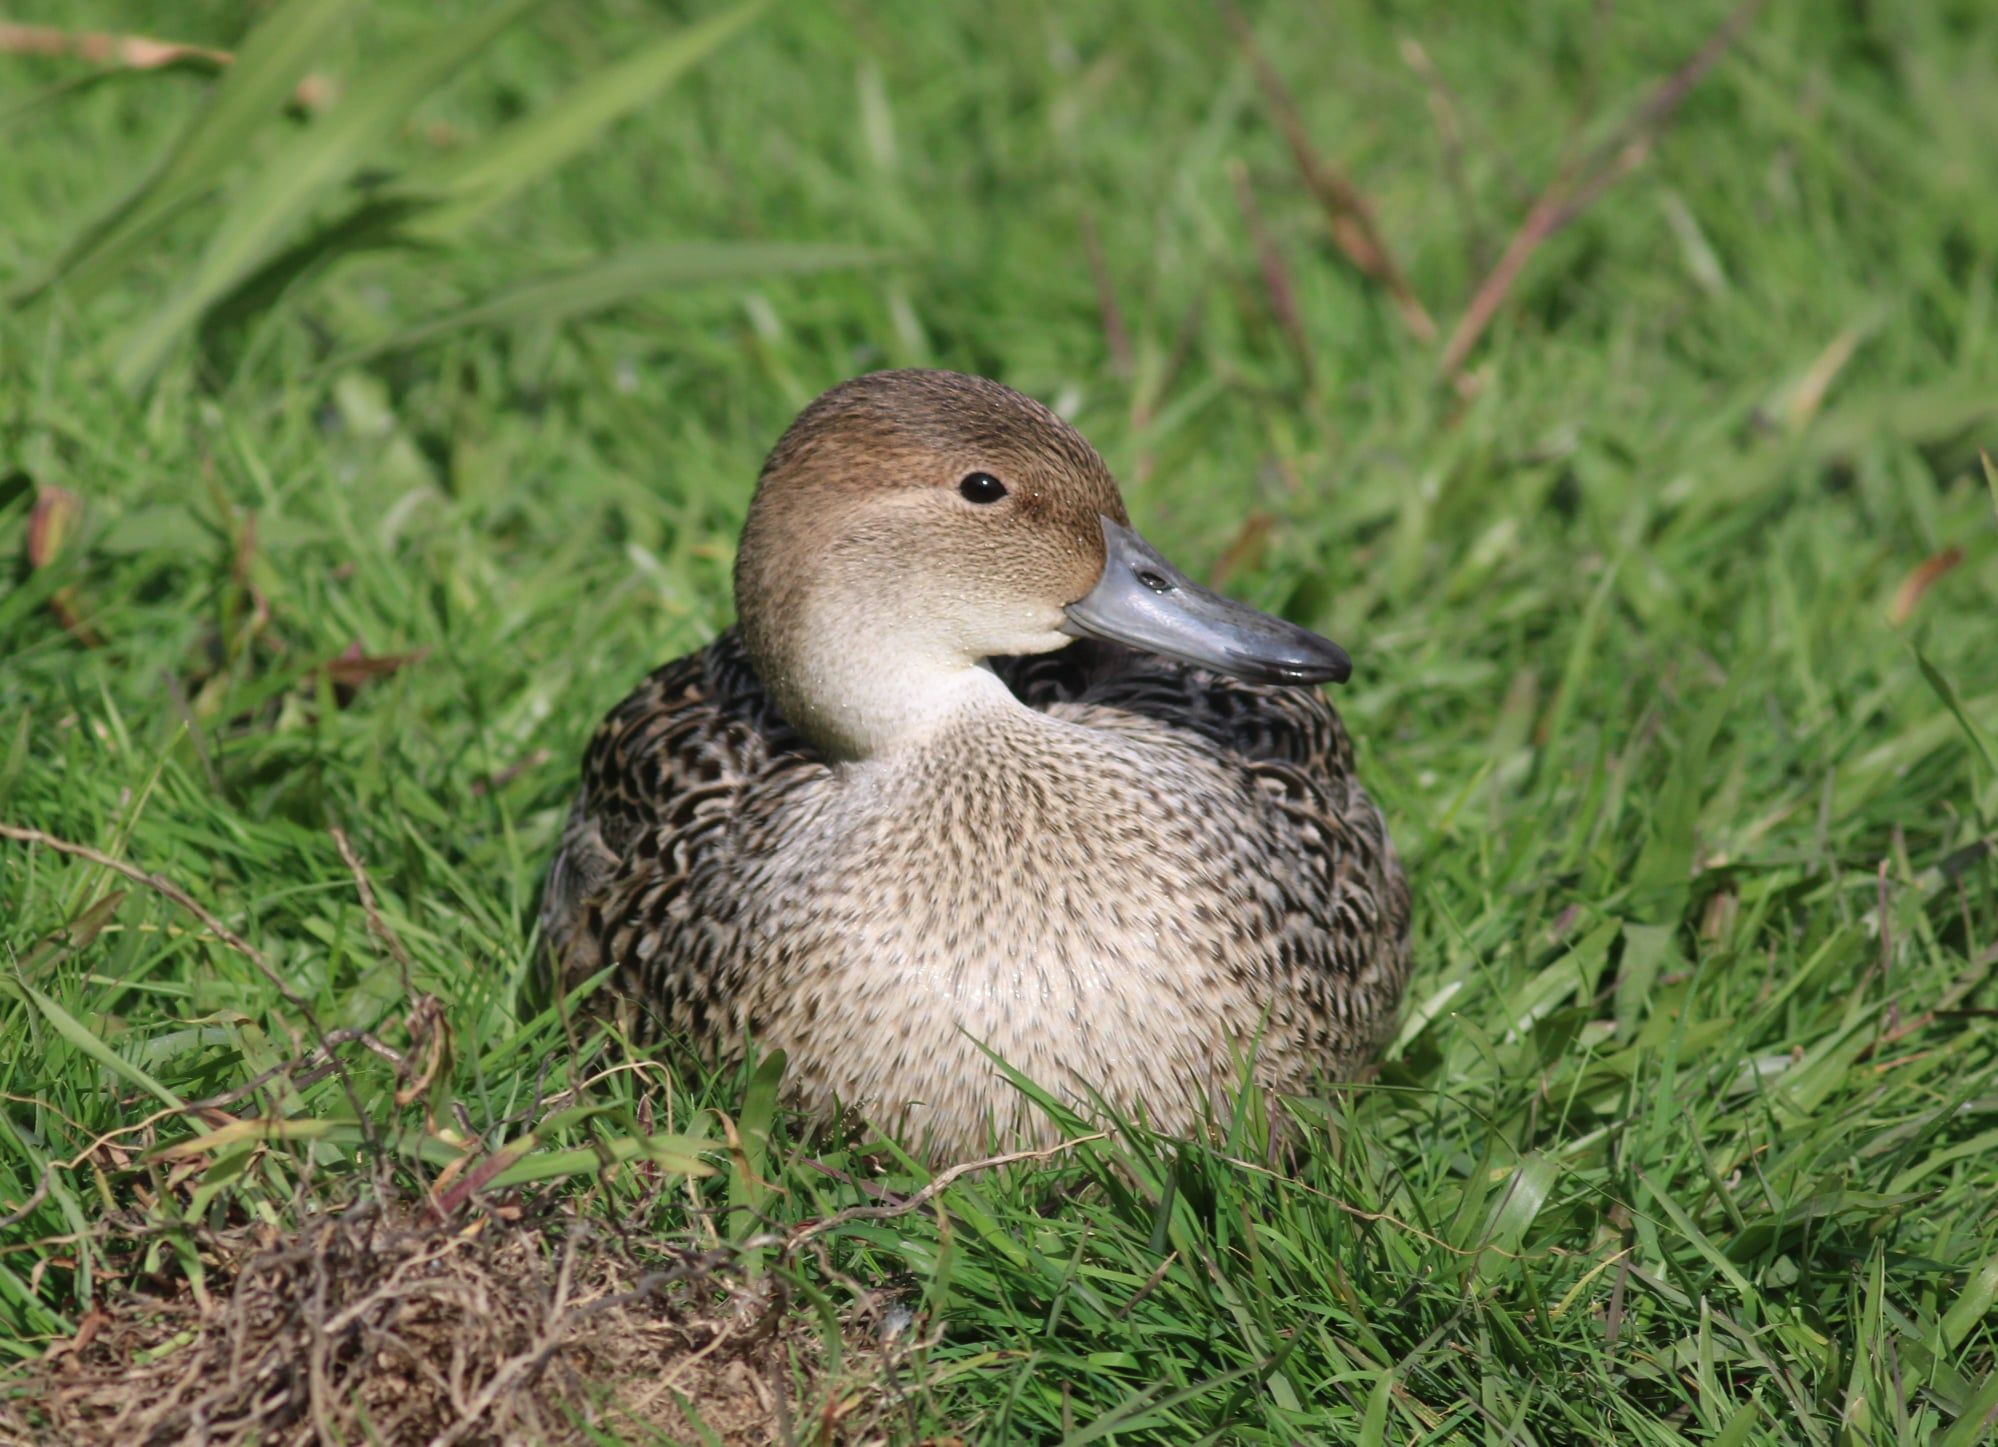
[[541, 628, 823, 983]]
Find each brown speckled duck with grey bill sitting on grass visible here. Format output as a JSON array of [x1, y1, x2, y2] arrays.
[[539, 370, 1411, 1161]]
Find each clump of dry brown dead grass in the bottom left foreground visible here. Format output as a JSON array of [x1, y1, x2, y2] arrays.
[[0, 1203, 881, 1447]]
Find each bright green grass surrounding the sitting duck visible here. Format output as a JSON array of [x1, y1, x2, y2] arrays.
[[0, 0, 1998, 1447]]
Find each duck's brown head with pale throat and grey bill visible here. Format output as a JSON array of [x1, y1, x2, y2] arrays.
[[735, 372, 1351, 757]]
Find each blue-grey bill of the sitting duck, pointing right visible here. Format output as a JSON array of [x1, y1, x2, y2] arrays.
[[1063, 518, 1353, 684]]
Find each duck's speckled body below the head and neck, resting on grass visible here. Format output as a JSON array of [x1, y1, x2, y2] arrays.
[[541, 632, 1409, 1153]]
